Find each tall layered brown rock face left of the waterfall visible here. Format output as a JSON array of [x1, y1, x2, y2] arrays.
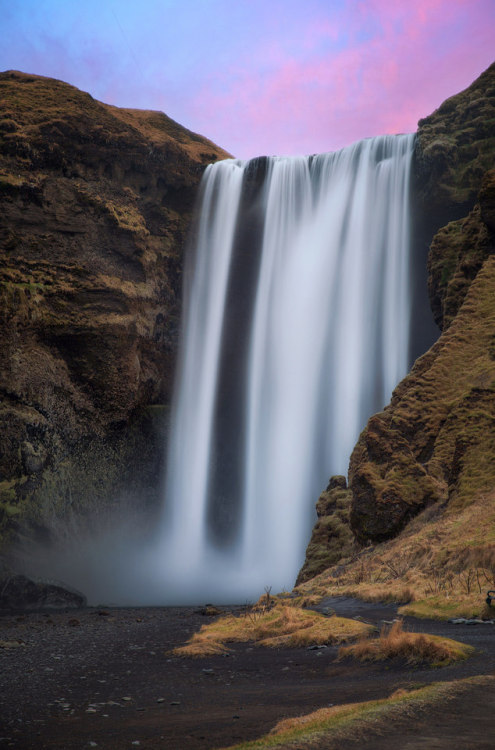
[[0, 72, 228, 548]]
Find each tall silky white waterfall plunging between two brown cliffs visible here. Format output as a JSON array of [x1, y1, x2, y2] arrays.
[[160, 135, 414, 602]]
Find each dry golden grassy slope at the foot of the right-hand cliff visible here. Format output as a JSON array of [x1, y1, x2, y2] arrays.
[[296, 492, 495, 619]]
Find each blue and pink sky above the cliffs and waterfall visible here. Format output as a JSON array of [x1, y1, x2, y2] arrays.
[[0, 0, 495, 159]]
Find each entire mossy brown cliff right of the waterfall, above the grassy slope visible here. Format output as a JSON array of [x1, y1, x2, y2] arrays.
[[300, 65, 495, 581]]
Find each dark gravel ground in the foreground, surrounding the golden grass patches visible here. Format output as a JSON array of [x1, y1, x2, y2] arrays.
[[0, 599, 495, 750]]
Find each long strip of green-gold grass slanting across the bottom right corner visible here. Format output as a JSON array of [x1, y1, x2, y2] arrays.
[[223, 676, 495, 750]]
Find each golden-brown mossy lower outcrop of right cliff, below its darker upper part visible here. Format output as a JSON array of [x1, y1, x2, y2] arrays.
[[349, 256, 495, 542]]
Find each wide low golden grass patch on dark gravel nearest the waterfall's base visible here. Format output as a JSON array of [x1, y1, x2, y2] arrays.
[[172, 603, 372, 657]]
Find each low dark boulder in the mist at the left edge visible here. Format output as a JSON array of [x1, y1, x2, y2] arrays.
[[0, 575, 87, 611]]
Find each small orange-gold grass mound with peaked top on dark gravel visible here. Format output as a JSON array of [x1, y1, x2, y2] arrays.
[[338, 620, 474, 667]]
